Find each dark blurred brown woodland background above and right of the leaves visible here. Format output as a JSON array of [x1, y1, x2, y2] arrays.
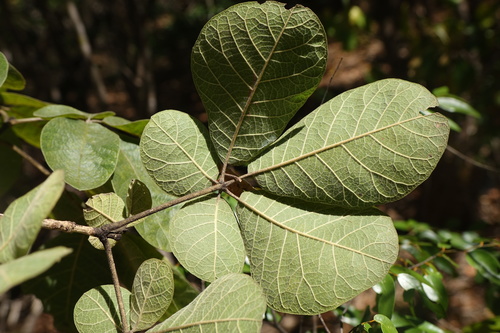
[[0, 0, 500, 330]]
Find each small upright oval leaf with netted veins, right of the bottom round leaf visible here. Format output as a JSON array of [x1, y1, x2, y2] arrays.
[[130, 259, 174, 331]]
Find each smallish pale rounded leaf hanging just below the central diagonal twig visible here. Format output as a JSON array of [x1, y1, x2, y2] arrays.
[[170, 195, 245, 282]]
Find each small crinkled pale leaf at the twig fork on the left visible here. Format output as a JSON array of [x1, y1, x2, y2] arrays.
[[83, 193, 125, 250]]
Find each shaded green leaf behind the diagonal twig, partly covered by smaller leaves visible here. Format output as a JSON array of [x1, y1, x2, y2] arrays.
[[111, 141, 180, 251]]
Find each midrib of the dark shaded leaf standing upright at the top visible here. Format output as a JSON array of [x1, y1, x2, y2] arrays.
[[219, 8, 295, 176]]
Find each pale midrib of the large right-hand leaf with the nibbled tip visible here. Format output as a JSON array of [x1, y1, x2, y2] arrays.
[[244, 113, 444, 179]]
